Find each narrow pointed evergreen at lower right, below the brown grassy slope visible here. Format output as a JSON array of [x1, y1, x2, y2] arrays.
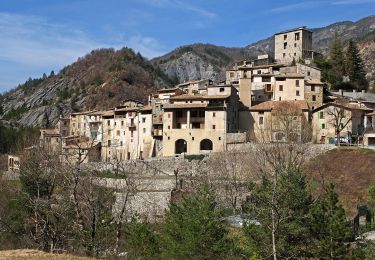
[[312, 184, 352, 259]]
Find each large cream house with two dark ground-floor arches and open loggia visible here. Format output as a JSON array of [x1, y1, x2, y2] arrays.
[[163, 85, 238, 156]]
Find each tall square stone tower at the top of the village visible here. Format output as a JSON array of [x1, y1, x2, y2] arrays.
[[275, 26, 314, 64]]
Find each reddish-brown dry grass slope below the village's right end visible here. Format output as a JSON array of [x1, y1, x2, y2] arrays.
[[305, 147, 375, 217]]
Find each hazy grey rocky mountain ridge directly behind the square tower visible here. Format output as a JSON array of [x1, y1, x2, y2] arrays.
[[152, 16, 375, 82]]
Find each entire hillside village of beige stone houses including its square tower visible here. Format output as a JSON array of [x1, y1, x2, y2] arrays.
[[8, 27, 375, 170]]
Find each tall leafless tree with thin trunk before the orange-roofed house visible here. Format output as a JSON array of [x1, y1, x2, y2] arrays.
[[250, 101, 311, 260]]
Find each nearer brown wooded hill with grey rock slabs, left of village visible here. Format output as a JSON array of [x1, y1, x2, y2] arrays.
[[0, 48, 172, 126]]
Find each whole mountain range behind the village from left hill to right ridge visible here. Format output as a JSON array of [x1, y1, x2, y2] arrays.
[[0, 16, 375, 126]]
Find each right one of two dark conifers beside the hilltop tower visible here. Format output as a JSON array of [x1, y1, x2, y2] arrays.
[[346, 40, 368, 90]]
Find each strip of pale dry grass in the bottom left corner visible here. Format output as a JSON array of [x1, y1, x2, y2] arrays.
[[0, 249, 90, 260]]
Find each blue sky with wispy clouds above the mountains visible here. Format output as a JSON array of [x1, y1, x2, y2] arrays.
[[0, 0, 375, 93]]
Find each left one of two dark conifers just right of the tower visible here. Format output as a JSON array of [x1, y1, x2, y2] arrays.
[[329, 34, 345, 88]]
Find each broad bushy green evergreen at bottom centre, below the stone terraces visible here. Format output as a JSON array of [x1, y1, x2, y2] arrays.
[[161, 191, 234, 259]]
